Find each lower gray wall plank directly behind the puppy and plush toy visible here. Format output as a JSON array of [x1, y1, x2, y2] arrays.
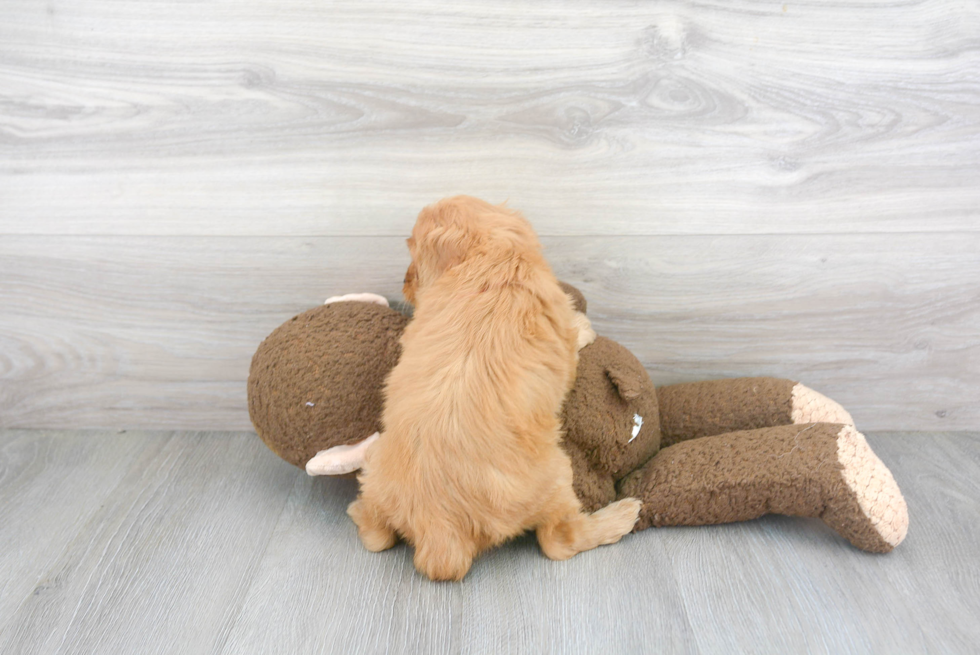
[[0, 233, 980, 429]]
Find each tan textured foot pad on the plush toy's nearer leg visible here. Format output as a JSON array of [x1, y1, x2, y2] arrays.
[[837, 425, 909, 550]]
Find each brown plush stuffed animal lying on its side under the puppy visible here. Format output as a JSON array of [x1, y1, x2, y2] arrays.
[[248, 286, 908, 552]]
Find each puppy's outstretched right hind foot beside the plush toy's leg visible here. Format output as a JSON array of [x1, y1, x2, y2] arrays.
[[537, 498, 642, 560]]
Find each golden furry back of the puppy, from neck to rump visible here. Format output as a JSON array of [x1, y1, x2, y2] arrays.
[[379, 210, 576, 543]]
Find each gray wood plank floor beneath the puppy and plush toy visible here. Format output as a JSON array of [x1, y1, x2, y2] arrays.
[[0, 430, 980, 654]]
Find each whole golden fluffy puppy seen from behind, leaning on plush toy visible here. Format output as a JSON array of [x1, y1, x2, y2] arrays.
[[348, 196, 640, 580]]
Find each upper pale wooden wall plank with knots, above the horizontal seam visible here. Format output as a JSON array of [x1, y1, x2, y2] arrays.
[[0, 0, 980, 236]]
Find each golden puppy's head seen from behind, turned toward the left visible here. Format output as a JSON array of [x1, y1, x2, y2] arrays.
[[402, 196, 540, 304]]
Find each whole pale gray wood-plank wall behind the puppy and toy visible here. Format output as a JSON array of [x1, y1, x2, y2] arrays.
[[0, 0, 980, 430]]
